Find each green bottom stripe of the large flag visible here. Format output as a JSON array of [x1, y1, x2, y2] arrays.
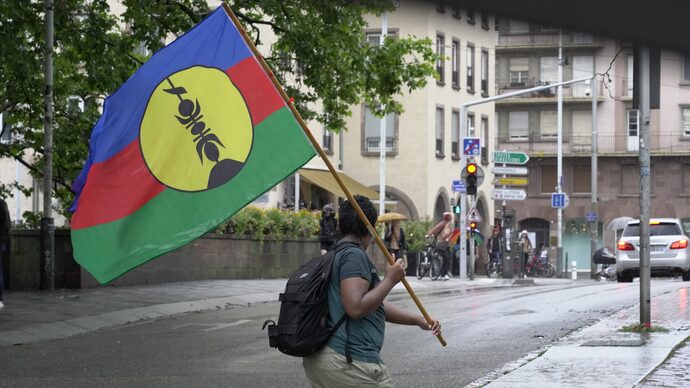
[[72, 107, 315, 283]]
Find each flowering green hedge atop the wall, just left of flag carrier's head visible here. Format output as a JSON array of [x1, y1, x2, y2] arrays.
[[215, 206, 319, 240]]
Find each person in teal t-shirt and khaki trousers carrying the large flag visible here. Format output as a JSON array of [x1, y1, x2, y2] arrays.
[[303, 195, 441, 387]]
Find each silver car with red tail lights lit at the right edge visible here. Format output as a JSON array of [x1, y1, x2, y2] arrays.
[[616, 218, 690, 283]]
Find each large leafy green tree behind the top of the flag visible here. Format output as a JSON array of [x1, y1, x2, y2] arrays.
[[0, 0, 436, 220]]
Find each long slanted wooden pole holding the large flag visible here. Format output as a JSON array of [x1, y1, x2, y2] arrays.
[[223, 3, 447, 346]]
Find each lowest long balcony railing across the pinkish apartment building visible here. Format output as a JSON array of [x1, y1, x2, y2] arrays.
[[497, 134, 690, 155]]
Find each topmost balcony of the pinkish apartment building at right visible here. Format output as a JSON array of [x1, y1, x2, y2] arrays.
[[496, 28, 604, 49]]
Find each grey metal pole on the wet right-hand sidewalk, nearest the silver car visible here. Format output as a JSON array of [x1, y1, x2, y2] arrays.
[[635, 45, 651, 327]]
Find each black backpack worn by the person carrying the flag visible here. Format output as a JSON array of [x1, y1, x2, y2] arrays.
[[263, 241, 359, 357]]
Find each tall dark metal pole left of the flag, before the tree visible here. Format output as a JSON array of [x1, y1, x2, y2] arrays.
[[41, 0, 55, 291]]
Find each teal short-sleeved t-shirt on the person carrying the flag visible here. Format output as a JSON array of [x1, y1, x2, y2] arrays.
[[328, 246, 386, 362]]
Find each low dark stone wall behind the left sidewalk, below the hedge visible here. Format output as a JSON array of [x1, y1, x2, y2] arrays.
[[3, 230, 319, 290]]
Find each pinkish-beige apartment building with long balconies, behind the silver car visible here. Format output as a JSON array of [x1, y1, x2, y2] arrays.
[[495, 19, 690, 271]]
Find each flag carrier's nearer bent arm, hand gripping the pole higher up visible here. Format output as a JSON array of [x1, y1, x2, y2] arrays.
[[340, 259, 405, 319]]
